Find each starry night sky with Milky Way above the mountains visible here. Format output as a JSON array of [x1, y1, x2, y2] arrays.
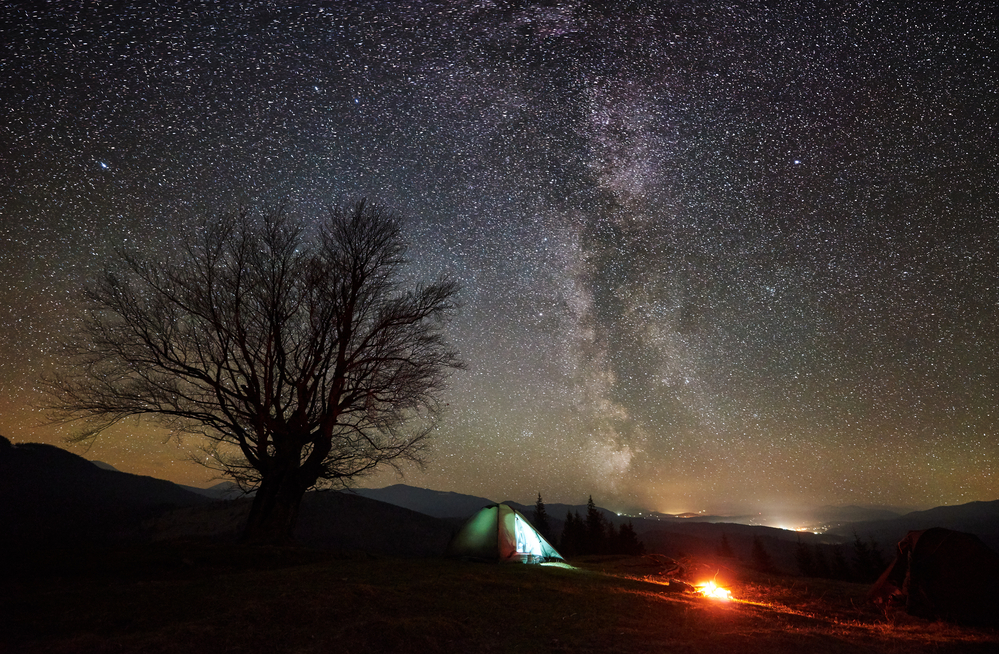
[[0, 0, 999, 512]]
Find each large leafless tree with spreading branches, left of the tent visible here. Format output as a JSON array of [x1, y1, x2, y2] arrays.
[[50, 200, 462, 543]]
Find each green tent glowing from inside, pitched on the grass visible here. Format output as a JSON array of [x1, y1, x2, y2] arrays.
[[444, 504, 563, 563]]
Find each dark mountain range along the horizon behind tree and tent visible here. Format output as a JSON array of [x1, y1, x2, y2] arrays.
[[0, 436, 999, 571]]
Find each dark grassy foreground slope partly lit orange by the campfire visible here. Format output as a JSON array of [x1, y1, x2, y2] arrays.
[[0, 545, 999, 654]]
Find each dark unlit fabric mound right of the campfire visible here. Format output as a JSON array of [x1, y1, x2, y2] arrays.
[[868, 527, 999, 626]]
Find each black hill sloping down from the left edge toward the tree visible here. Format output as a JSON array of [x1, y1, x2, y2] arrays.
[[0, 436, 210, 547]]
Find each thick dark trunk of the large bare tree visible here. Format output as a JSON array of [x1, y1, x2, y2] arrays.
[[241, 468, 311, 545]]
